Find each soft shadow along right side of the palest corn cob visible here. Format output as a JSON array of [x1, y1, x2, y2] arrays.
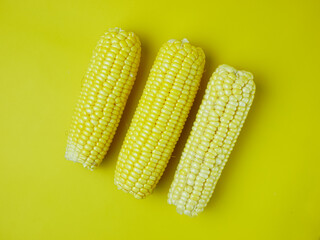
[[205, 71, 267, 212]]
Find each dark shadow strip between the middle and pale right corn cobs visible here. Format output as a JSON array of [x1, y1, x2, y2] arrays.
[[154, 52, 216, 194]]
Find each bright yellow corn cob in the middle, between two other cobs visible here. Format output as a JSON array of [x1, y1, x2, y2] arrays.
[[115, 39, 205, 199]]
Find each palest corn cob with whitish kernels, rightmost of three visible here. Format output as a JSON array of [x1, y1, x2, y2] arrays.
[[168, 65, 255, 216]]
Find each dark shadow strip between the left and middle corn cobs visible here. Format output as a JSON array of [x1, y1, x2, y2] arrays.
[[100, 32, 155, 168]]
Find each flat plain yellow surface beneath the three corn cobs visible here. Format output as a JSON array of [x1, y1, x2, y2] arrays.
[[0, 0, 320, 240]]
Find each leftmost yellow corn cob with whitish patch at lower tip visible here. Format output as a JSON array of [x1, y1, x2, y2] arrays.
[[65, 28, 141, 169]]
